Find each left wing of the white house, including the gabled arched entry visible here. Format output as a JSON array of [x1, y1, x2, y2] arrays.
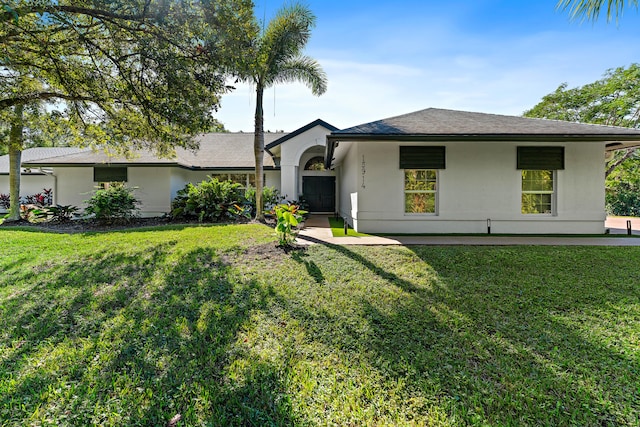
[[6, 120, 337, 216]]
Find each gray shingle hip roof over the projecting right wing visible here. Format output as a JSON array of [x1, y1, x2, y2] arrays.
[[332, 108, 640, 138]]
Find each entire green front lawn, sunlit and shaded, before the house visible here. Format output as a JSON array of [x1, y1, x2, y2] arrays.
[[0, 225, 640, 426]]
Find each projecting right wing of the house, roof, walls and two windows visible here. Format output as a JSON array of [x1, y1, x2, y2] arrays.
[[325, 108, 640, 234]]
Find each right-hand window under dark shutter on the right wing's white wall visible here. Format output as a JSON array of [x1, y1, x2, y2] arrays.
[[522, 170, 555, 214]]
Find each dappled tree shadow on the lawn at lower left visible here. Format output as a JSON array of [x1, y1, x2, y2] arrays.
[[0, 242, 294, 426]]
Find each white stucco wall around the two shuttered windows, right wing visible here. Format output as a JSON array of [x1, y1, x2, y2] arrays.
[[340, 141, 605, 234]]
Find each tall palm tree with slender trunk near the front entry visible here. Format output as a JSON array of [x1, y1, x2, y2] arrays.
[[239, 3, 327, 219]]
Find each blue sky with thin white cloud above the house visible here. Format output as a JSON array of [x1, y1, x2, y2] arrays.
[[216, 0, 640, 132]]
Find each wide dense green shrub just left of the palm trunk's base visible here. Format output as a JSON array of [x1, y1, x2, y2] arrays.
[[171, 177, 245, 222]]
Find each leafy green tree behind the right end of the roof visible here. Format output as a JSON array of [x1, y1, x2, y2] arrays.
[[524, 64, 640, 176]]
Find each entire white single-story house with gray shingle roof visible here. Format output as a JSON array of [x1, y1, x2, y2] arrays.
[[0, 108, 640, 234]]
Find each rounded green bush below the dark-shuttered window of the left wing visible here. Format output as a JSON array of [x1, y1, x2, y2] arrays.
[[84, 183, 140, 222]]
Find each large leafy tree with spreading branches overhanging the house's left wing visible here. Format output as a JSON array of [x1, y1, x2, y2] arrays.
[[0, 0, 251, 218]]
